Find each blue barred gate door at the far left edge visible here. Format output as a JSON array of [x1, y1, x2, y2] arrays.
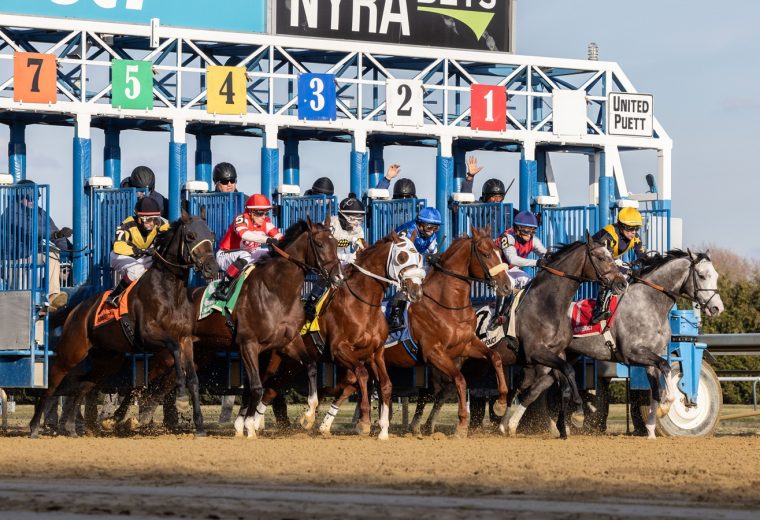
[[0, 184, 51, 388]]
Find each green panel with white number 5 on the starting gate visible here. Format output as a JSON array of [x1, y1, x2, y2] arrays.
[[111, 60, 153, 110]]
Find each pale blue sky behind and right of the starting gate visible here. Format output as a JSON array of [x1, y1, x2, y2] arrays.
[[0, 0, 760, 258]]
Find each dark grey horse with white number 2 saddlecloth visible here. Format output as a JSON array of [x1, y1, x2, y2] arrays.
[[500, 237, 628, 439]]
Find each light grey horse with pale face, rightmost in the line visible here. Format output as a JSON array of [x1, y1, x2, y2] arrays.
[[568, 250, 724, 439]]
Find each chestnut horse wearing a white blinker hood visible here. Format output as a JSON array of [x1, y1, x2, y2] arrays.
[[254, 232, 425, 440]]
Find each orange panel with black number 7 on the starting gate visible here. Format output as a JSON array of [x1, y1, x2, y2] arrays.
[[13, 52, 57, 103]]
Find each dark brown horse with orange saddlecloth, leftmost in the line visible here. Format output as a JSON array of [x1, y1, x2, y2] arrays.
[[29, 210, 219, 438]]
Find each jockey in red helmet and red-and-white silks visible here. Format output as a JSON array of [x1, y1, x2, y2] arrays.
[[214, 193, 282, 299]]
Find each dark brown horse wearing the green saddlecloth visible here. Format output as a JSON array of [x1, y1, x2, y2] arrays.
[[193, 215, 343, 438]]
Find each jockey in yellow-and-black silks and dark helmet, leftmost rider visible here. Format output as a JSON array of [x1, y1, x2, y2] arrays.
[[107, 197, 169, 307]]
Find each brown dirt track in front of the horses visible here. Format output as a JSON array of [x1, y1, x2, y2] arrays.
[[0, 424, 760, 518]]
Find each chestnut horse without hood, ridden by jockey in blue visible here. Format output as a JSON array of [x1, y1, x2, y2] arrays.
[[385, 227, 511, 437]]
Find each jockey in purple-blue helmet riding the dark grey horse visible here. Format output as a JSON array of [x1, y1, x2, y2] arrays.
[[489, 211, 546, 329]]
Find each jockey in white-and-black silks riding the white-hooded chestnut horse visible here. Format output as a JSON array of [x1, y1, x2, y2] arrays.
[[304, 193, 367, 321]]
